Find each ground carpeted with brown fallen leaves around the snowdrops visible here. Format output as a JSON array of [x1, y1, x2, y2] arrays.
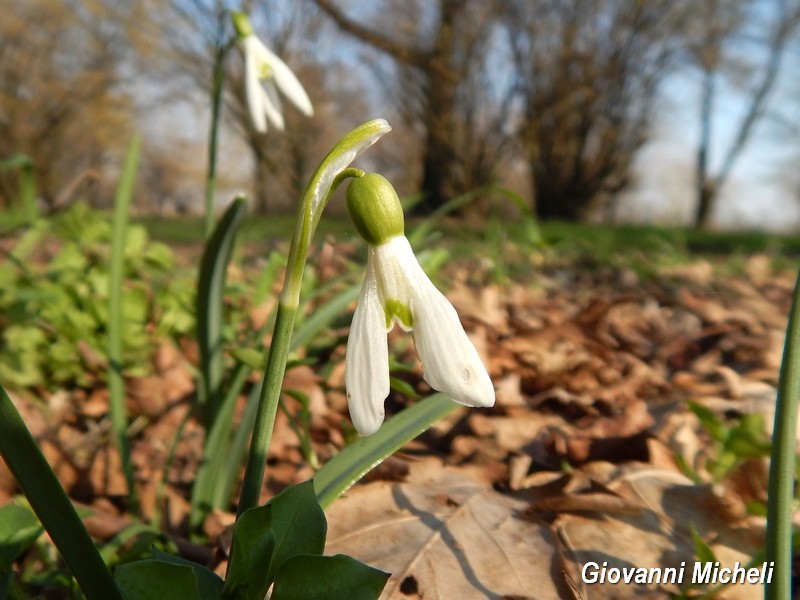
[[0, 219, 796, 600]]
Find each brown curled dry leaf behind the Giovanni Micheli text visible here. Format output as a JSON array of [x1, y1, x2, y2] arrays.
[[554, 467, 763, 600]]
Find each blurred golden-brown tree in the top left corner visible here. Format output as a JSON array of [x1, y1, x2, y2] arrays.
[[0, 0, 136, 206]]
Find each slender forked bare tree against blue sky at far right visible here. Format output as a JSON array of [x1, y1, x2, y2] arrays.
[[685, 0, 800, 227]]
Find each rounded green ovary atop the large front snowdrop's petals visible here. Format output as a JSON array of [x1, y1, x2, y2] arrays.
[[346, 173, 404, 246]]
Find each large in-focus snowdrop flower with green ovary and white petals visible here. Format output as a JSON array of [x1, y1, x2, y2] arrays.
[[345, 173, 495, 435]]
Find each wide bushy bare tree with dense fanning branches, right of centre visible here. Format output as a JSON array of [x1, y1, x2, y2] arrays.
[[507, 0, 684, 220]]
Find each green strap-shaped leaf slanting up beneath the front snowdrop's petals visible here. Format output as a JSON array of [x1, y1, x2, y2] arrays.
[[314, 394, 460, 508]]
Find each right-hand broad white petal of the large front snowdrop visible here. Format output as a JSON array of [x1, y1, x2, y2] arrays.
[[392, 236, 495, 407]]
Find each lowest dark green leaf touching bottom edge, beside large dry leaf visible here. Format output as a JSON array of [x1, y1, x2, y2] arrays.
[[271, 554, 389, 600]]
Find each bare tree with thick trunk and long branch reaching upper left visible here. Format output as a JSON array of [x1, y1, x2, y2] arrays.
[[314, 0, 509, 213]]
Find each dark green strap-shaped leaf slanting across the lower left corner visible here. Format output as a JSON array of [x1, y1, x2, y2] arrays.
[[0, 386, 122, 600]]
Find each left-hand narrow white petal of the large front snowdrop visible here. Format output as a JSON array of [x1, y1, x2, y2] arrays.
[[344, 261, 389, 435]]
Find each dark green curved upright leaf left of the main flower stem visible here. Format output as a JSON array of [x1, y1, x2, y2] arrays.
[[197, 197, 245, 429]]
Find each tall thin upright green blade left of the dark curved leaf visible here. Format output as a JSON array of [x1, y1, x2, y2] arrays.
[[108, 135, 141, 513]]
